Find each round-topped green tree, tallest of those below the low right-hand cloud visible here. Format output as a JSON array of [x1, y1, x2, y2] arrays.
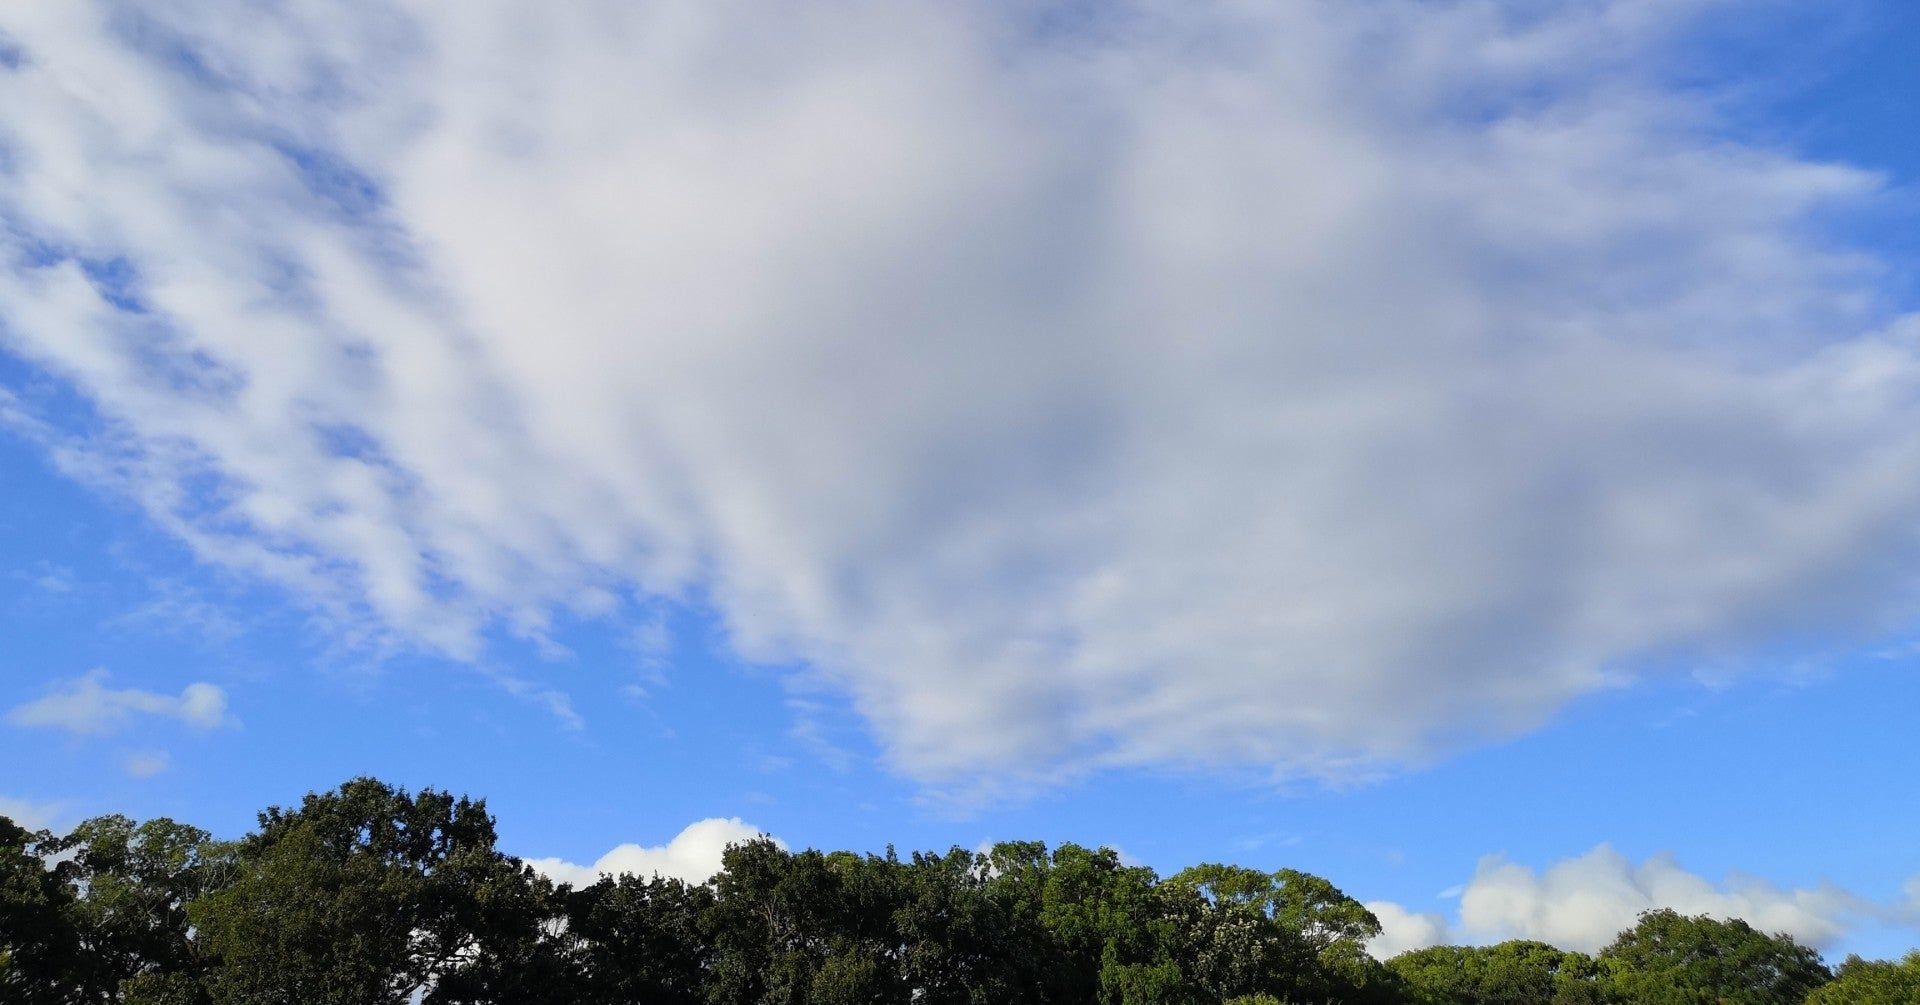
[[1599, 909, 1832, 1005]]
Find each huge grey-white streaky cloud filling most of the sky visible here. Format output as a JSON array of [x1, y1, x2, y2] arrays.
[[0, 0, 1920, 780]]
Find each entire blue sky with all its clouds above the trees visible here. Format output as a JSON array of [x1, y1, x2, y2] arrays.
[[0, 0, 1920, 959]]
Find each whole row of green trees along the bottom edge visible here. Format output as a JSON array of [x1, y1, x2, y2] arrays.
[[0, 778, 1920, 1005]]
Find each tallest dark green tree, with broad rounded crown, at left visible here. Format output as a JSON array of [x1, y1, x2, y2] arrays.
[[188, 778, 545, 1005]]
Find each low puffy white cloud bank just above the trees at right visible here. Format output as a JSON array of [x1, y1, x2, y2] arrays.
[[1367, 844, 1920, 959]]
